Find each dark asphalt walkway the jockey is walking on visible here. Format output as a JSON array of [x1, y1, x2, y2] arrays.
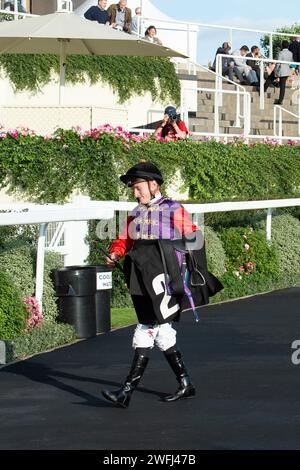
[[0, 288, 300, 450]]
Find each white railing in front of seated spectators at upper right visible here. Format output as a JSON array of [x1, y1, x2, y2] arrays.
[[216, 54, 300, 110]]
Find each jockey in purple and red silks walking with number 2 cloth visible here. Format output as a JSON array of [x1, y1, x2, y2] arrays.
[[102, 162, 222, 408]]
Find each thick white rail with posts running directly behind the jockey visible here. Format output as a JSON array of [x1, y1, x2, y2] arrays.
[[0, 198, 300, 309]]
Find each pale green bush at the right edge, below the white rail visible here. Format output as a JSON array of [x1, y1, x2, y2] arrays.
[[254, 215, 300, 274]]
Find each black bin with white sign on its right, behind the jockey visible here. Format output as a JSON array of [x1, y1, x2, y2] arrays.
[[53, 265, 112, 338]]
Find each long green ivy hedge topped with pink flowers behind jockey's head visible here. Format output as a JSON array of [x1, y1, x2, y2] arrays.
[[0, 130, 300, 202]]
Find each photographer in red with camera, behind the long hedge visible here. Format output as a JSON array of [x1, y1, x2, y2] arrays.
[[153, 106, 189, 140]]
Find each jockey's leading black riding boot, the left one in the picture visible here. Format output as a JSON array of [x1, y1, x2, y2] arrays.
[[102, 351, 149, 408]]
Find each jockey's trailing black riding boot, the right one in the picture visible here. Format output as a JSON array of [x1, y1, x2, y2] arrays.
[[163, 351, 196, 401]]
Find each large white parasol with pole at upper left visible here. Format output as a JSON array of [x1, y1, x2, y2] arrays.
[[0, 10, 186, 104]]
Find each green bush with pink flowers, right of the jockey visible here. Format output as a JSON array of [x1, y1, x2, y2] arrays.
[[220, 227, 279, 278]]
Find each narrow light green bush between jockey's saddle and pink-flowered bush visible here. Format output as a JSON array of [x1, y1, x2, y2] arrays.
[[204, 227, 226, 277]]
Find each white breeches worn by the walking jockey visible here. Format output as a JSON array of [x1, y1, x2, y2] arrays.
[[132, 323, 177, 351]]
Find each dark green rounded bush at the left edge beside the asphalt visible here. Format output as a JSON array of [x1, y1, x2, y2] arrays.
[[0, 271, 28, 340]]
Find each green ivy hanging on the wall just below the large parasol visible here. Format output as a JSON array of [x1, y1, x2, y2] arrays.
[[0, 54, 180, 105]]
